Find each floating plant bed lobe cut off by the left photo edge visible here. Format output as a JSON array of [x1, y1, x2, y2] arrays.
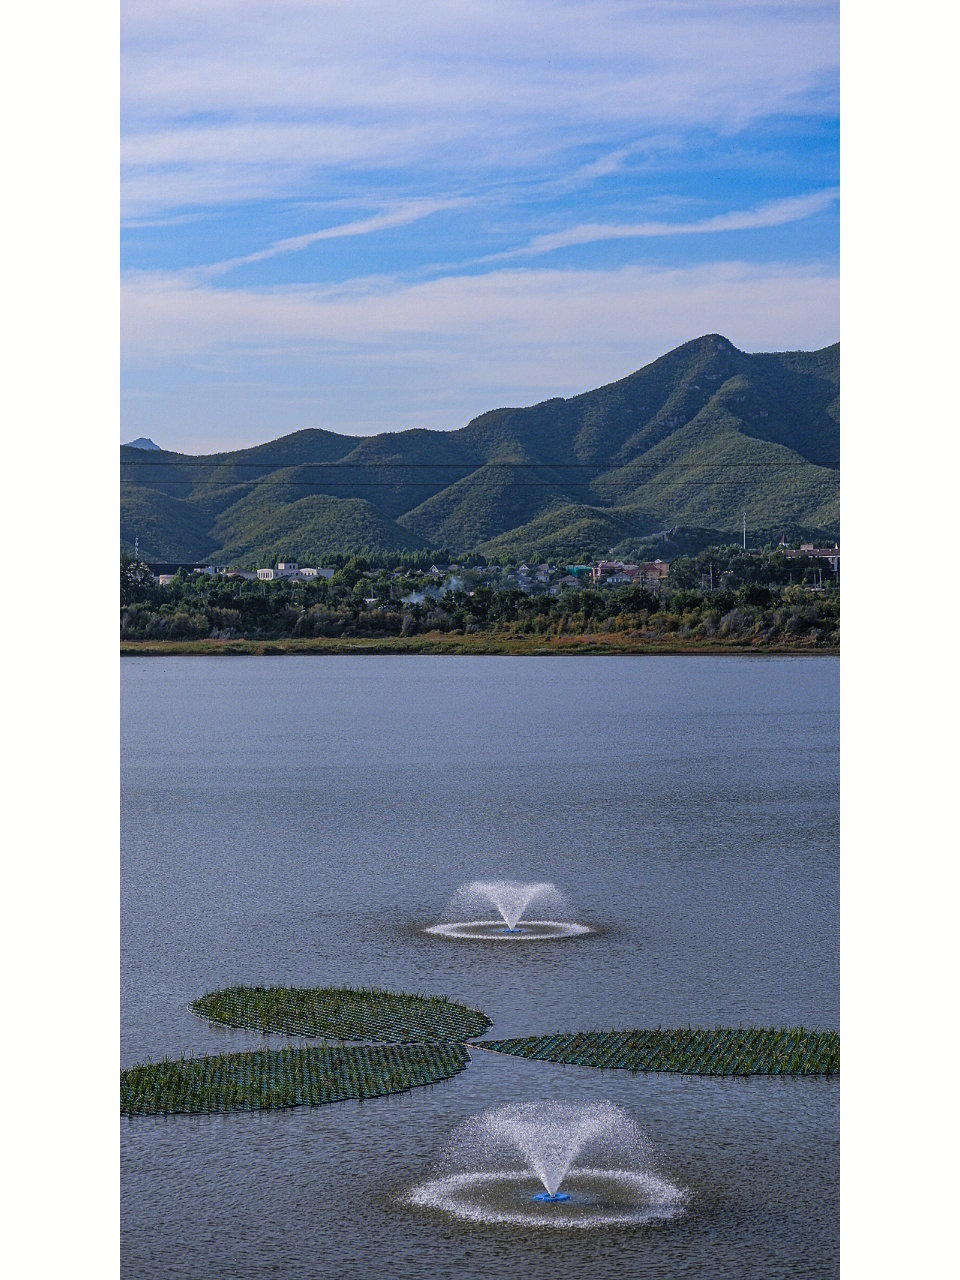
[[120, 1044, 470, 1115]]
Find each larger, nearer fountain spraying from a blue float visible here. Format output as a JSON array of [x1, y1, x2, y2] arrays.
[[410, 1102, 687, 1228]]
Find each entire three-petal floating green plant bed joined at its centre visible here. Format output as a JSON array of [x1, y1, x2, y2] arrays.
[[120, 987, 840, 1115]]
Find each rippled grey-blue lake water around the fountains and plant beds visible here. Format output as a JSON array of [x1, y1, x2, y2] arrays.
[[122, 655, 838, 1280]]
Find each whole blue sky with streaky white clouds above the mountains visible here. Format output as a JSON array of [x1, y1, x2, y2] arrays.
[[122, 0, 838, 452]]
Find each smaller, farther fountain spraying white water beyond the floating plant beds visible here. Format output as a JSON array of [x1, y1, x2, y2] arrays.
[[426, 879, 591, 942]]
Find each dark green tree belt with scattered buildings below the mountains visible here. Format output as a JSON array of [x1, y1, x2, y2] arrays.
[[120, 548, 840, 648]]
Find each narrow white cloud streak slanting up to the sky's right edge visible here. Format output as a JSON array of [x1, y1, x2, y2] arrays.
[[483, 187, 840, 262]]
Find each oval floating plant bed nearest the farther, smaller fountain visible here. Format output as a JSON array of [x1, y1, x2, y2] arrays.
[[191, 987, 490, 1042]]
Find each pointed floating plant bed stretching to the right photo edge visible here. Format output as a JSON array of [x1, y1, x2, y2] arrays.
[[475, 1027, 840, 1075]]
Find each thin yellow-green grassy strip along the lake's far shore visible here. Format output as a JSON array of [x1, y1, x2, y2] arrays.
[[120, 632, 840, 658]]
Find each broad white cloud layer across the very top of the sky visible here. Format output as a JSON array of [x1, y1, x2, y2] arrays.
[[122, 0, 837, 214]]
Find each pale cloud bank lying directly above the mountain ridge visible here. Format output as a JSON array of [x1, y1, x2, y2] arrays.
[[123, 262, 838, 448]]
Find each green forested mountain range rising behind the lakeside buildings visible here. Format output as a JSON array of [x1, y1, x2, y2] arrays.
[[120, 334, 840, 564]]
